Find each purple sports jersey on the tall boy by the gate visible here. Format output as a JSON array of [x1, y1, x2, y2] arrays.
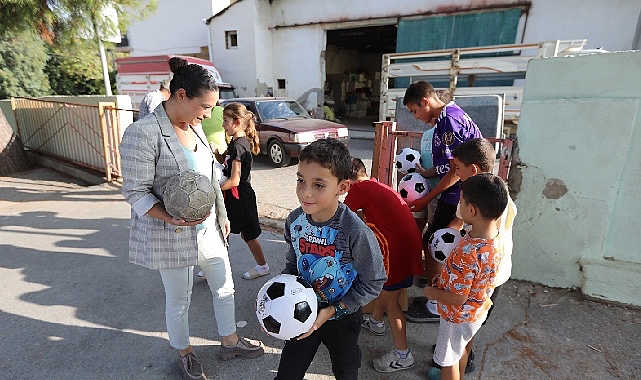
[[432, 102, 483, 204]]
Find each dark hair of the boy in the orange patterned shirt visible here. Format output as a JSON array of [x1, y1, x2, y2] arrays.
[[461, 173, 508, 220]]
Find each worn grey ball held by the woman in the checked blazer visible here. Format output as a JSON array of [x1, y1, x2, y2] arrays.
[[163, 170, 216, 221]]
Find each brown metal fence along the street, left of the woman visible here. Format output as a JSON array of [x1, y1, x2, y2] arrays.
[[11, 98, 121, 181]]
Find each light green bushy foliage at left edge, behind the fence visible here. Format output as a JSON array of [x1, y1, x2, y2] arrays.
[[0, 32, 51, 99]]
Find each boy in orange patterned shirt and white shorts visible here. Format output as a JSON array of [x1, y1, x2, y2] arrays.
[[423, 173, 508, 380]]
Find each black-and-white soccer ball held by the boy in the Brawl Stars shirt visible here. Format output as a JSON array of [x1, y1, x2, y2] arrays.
[[256, 274, 318, 340]]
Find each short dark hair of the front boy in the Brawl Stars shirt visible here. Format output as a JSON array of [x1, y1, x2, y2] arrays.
[[298, 138, 352, 182]]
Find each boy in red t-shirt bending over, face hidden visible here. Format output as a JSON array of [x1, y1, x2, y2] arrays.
[[344, 157, 423, 372]]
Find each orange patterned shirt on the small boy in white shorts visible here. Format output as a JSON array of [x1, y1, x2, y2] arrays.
[[436, 234, 502, 323]]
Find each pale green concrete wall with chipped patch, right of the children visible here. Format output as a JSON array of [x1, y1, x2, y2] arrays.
[[510, 51, 641, 305]]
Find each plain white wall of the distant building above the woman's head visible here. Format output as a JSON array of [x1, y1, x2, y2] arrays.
[[127, 0, 230, 56]]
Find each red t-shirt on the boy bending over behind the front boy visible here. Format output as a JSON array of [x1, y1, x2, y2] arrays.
[[345, 178, 423, 285]]
